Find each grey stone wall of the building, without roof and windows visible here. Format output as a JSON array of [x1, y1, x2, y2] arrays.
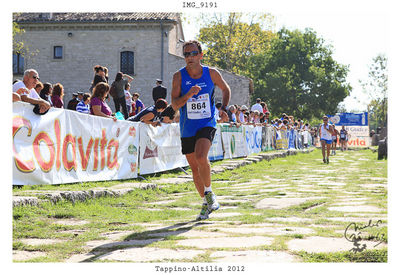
[[14, 24, 250, 110]]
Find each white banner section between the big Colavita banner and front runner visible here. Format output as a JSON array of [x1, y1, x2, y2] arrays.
[[139, 123, 189, 175]]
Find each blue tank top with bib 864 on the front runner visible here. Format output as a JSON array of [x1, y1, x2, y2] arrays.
[[179, 66, 217, 137]]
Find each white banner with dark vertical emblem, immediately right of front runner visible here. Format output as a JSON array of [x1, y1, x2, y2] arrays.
[[221, 124, 248, 159]]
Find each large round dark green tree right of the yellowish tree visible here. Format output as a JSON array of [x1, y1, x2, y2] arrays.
[[247, 28, 351, 119]]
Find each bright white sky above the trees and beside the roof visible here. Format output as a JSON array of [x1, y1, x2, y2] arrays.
[[183, 9, 389, 111]]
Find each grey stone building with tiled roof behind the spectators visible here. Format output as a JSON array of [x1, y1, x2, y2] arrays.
[[13, 12, 251, 107]]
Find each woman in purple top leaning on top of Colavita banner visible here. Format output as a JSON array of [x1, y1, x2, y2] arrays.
[[90, 82, 117, 121]]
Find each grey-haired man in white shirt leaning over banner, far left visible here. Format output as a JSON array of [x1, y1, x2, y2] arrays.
[[13, 69, 50, 114]]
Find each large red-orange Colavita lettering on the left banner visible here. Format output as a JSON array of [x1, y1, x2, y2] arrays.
[[13, 116, 119, 173]]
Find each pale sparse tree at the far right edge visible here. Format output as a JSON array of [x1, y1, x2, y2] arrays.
[[360, 54, 388, 132]]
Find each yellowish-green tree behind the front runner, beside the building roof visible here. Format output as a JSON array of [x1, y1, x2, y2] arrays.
[[197, 13, 273, 74]]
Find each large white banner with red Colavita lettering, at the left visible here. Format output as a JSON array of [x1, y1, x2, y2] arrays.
[[13, 102, 139, 185]]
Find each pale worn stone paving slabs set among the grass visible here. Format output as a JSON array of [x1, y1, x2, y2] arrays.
[[13, 149, 387, 263]]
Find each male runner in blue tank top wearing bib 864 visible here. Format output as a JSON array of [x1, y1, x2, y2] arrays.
[[171, 40, 231, 220]]
